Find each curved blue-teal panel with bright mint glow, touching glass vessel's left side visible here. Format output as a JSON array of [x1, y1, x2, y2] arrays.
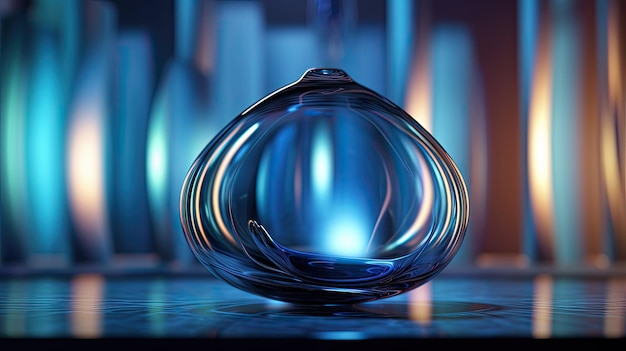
[[146, 60, 208, 266]]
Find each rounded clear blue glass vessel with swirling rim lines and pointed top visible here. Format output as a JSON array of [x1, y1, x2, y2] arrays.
[[180, 69, 469, 305]]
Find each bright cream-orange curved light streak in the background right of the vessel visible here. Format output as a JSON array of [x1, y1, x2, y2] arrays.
[[528, 24, 554, 252]]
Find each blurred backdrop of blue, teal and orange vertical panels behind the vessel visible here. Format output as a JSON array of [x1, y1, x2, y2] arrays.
[[0, 0, 626, 272]]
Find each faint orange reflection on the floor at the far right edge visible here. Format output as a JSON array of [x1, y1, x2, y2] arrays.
[[604, 278, 626, 338]]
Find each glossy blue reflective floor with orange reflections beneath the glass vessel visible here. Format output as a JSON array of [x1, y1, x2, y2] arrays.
[[0, 273, 626, 346]]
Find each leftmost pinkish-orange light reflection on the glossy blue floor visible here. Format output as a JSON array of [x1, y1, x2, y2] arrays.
[[72, 274, 104, 338]]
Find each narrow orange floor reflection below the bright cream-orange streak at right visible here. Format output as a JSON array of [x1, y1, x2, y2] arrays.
[[532, 274, 553, 339]]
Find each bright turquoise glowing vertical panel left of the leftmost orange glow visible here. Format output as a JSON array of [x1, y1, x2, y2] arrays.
[[26, 25, 70, 266]]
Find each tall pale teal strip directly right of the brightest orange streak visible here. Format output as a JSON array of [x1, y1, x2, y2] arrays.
[[546, 0, 584, 266]]
